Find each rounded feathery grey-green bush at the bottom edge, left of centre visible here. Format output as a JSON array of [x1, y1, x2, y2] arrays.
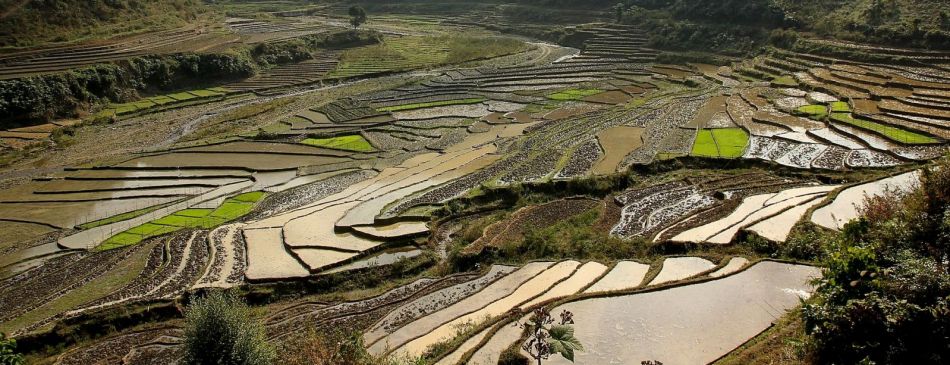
[[184, 291, 276, 365]]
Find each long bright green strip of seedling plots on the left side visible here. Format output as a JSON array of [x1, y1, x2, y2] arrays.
[[96, 191, 264, 251]]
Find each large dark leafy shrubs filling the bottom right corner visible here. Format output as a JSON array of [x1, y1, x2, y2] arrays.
[[803, 162, 950, 364]]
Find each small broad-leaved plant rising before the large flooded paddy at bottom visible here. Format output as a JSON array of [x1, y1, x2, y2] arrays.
[[521, 307, 584, 365]]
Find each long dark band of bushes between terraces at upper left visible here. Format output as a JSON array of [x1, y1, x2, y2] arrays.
[[0, 31, 380, 129]]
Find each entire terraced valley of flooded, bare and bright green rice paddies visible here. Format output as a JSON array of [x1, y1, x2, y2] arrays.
[[0, 4, 950, 364]]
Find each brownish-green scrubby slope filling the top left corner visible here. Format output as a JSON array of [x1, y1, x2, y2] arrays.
[[0, 0, 205, 48]]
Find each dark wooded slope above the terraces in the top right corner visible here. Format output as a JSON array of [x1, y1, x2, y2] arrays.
[[621, 0, 950, 54]]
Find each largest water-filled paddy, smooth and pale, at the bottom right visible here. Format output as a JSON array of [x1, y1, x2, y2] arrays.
[[548, 262, 819, 364]]
